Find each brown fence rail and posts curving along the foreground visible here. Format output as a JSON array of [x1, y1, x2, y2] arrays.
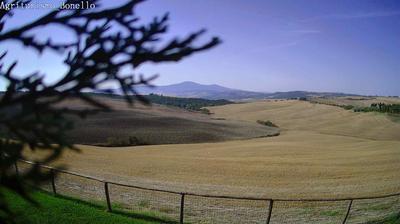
[[15, 159, 400, 224]]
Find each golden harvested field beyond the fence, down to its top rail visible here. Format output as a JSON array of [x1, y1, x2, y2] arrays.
[[25, 100, 400, 198]]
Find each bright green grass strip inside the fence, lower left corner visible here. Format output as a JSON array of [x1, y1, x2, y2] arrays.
[[2, 191, 173, 224]]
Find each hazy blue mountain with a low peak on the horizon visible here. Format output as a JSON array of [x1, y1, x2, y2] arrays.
[[137, 82, 269, 100]]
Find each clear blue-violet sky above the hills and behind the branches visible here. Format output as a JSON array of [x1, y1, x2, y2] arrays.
[[0, 0, 400, 95]]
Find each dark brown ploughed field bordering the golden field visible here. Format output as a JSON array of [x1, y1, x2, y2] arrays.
[[60, 97, 279, 146]]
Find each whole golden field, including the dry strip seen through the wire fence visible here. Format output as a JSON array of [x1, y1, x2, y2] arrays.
[[22, 101, 400, 224]]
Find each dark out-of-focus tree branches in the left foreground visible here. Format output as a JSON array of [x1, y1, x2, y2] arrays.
[[0, 0, 220, 222]]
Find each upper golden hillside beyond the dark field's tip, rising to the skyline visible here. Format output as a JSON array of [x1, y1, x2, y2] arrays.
[[210, 100, 400, 140]]
